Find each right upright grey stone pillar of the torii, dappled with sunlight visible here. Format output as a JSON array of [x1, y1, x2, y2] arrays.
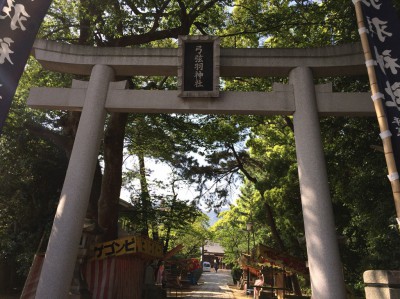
[[289, 67, 346, 299]]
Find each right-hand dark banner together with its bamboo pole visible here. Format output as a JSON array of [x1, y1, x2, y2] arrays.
[[353, 0, 400, 220]]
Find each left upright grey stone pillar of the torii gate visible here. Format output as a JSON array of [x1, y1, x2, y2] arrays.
[[36, 65, 114, 299]]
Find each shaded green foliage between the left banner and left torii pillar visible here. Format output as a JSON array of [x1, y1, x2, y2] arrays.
[[0, 60, 71, 291]]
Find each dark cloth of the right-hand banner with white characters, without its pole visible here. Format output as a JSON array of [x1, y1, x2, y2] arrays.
[[361, 0, 400, 171]]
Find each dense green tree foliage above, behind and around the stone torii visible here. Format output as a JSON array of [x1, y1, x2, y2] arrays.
[[0, 0, 400, 294]]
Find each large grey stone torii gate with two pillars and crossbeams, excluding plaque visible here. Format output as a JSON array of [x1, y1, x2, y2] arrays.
[[28, 40, 375, 299]]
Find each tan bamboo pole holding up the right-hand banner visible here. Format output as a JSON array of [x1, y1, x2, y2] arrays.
[[353, 0, 400, 226]]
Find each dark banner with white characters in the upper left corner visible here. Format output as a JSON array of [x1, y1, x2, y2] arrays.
[[0, 0, 51, 134]]
